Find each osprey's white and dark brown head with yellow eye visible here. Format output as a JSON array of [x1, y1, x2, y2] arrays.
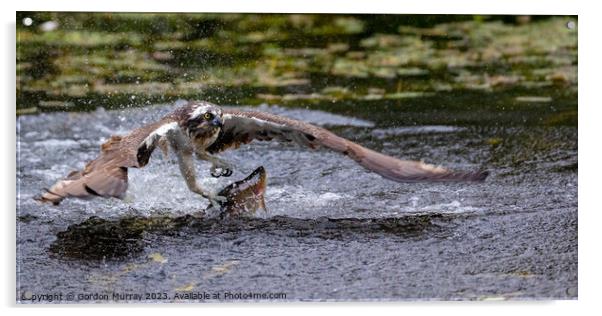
[[180, 102, 222, 139]]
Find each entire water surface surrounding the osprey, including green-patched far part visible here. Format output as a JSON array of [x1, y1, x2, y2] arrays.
[[17, 13, 578, 301]]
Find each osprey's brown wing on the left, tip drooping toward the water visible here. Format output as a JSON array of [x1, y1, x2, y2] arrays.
[[36, 117, 173, 205]]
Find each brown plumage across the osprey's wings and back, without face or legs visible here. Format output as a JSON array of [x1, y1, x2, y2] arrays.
[[37, 102, 488, 204]]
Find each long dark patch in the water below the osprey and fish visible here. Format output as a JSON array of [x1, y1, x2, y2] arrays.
[[50, 214, 442, 260]]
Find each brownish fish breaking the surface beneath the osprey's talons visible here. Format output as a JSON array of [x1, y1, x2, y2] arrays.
[[205, 166, 267, 218]]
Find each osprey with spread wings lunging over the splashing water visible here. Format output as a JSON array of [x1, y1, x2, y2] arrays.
[[37, 102, 489, 205]]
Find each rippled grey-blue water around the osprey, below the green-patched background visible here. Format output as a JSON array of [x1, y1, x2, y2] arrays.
[[17, 102, 577, 302]]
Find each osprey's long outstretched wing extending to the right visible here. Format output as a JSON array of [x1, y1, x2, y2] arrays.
[[207, 110, 489, 182]]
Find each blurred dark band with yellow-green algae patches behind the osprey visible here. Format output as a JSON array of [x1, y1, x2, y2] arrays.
[[17, 12, 578, 125]]
